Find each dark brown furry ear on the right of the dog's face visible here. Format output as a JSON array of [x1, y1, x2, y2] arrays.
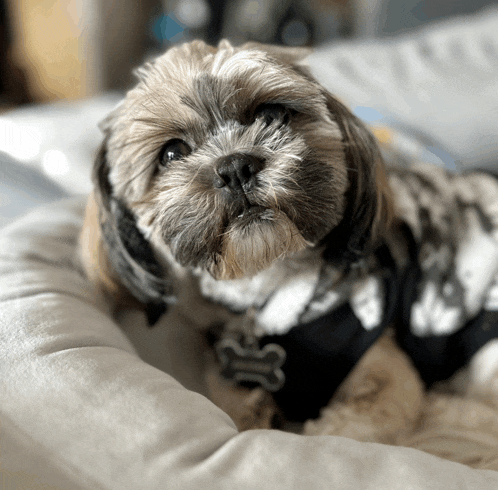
[[324, 91, 393, 263]]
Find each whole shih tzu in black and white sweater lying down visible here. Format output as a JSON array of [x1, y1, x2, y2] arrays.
[[81, 41, 498, 440]]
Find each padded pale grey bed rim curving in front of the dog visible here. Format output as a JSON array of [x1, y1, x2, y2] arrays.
[[0, 198, 498, 490]]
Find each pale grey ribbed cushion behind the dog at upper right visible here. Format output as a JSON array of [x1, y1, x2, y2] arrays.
[[308, 7, 498, 168]]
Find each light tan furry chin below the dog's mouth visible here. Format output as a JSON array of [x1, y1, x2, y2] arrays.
[[207, 209, 311, 280]]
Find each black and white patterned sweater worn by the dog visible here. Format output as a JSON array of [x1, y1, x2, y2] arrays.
[[199, 165, 498, 419]]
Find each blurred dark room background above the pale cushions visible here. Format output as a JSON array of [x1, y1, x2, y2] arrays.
[[0, 0, 494, 104]]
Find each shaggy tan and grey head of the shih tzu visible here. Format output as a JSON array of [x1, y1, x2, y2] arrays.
[[90, 41, 387, 306]]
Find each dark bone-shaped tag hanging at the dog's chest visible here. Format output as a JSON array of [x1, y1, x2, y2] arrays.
[[216, 338, 286, 391]]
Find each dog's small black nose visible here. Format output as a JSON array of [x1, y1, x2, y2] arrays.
[[213, 153, 264, 193]]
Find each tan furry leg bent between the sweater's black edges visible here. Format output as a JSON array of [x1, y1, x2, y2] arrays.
[[303, 333, 424, 444]]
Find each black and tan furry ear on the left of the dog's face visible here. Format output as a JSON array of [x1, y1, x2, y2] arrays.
[[82, 138, 174, 324]]
